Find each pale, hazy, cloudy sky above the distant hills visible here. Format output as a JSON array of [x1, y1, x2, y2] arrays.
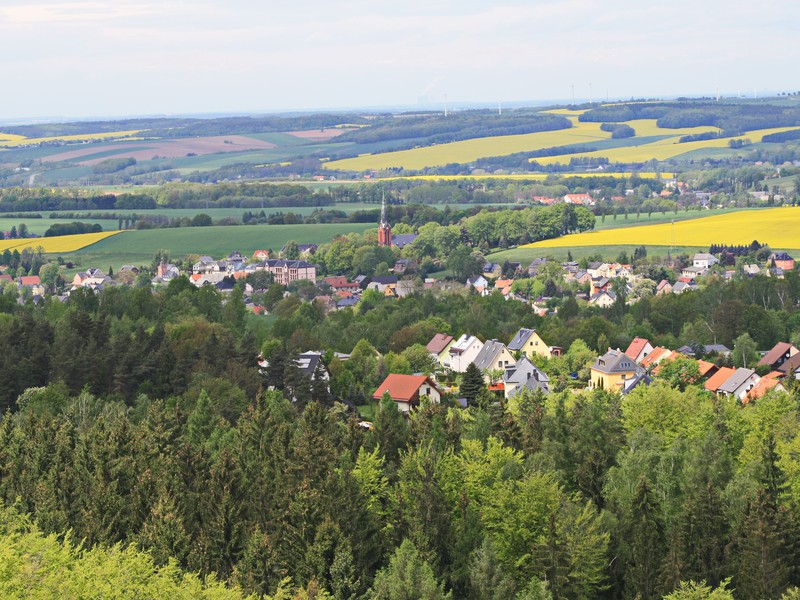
[[0, 0, 800, 121]]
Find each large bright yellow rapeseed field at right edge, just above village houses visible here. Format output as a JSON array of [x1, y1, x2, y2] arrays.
[[525, 208, 800, 250]]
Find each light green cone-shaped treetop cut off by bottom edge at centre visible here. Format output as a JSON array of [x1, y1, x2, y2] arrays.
[[370, 540, 452, 600]]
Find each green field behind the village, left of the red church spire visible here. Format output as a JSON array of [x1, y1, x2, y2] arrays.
[[62, 223, 375, 269]]
